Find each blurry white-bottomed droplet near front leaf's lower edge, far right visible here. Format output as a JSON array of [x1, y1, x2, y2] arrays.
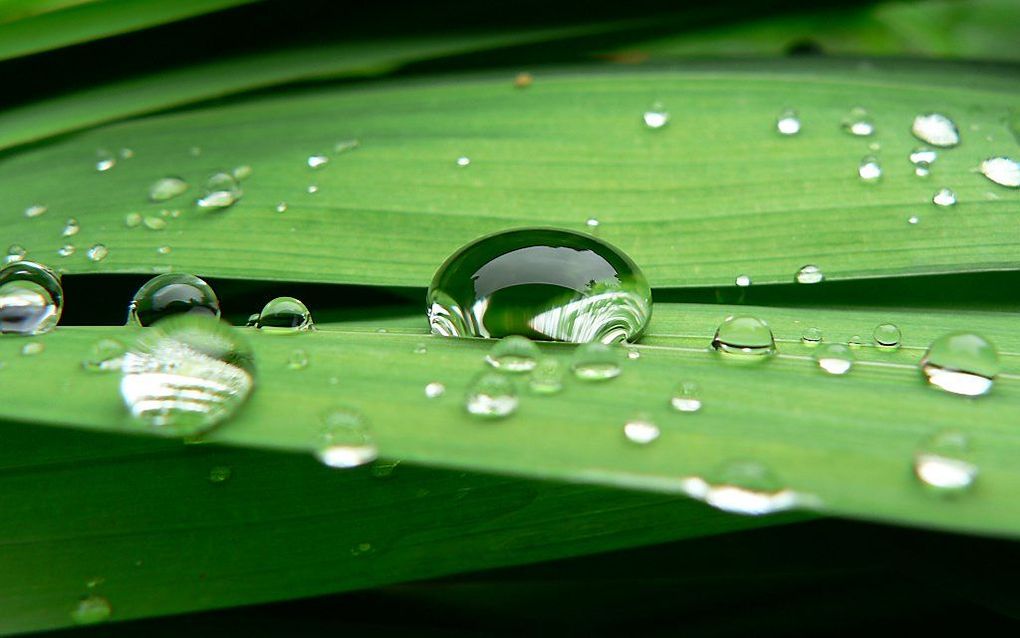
[[914, 430, 978, 496]]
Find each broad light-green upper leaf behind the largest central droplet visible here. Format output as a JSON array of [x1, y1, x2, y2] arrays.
[[0, 61, 1020, 288]]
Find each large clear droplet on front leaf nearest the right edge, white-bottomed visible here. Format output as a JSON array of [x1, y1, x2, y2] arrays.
[[921, 333, 1000, 396]]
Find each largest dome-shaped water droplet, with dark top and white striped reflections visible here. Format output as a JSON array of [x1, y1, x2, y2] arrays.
[[427, 229, 652, 343]]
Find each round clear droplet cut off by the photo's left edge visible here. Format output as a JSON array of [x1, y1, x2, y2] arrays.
[[0, 261, 63, 335]]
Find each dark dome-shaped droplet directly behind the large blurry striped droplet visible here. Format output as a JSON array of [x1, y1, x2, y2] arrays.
[[128, 273, 219, 326]]
